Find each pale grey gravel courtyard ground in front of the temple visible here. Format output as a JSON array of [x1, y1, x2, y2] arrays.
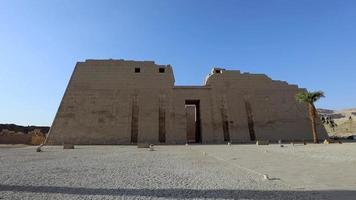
[[0, 143, 356, 199]]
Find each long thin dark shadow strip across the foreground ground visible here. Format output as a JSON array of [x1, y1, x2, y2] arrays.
[[0, 184, 356, 199]]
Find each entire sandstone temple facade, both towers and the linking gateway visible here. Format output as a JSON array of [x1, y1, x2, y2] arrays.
[[48, 60, 327, 144]]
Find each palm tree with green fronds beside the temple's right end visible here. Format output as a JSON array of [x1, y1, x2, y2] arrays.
[[295, 90, 325, 143]]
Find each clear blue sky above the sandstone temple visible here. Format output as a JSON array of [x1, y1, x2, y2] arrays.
[[0, 0, 356, 125]]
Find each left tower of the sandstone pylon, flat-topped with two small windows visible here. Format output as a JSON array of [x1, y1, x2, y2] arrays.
[[49, 60, 174, 144]]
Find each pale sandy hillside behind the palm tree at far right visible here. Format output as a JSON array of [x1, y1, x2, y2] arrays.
[[317, 108, 356, 137]]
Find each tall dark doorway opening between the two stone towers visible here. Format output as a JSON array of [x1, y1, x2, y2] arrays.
[[185, 100, 201, 143]]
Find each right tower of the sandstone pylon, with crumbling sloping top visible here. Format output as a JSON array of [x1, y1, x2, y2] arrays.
[[206, 70, 327, 142]]
